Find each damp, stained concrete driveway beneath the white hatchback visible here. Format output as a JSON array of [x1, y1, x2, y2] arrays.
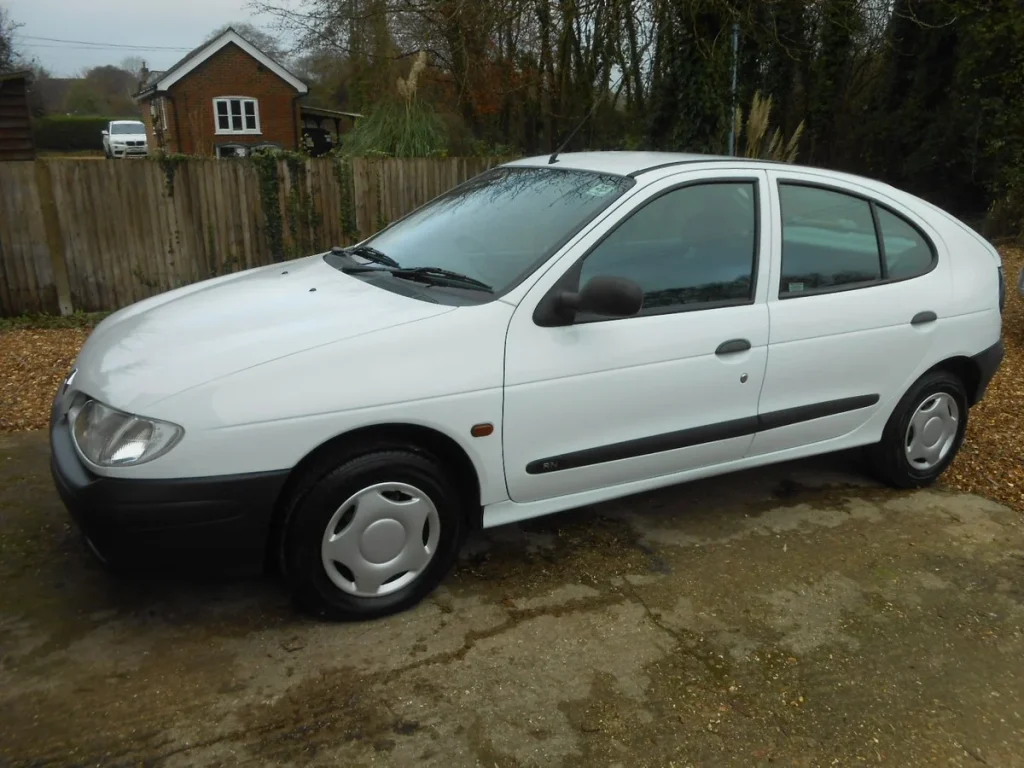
[[0, 434, 1024, 768]]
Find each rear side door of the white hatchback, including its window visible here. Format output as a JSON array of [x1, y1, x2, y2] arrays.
[[751, 170, 952, 456]]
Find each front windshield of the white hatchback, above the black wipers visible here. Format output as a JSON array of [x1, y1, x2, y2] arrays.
[[356, 167, 633, 294]]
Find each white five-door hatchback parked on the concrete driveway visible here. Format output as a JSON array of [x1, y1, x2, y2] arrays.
[[51, 153, 1004, 617]]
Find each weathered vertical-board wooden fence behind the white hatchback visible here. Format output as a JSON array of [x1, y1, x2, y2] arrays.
[[0, 158, 501, 315]]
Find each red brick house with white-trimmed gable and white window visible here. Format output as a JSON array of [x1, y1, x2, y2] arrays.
[[135, 29, 308, 158]]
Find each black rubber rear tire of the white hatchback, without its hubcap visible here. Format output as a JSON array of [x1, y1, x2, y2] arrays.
[[867, 371, 968, 488]]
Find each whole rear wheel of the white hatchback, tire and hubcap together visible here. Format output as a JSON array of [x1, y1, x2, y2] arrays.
[[868, 371, 968, 488]]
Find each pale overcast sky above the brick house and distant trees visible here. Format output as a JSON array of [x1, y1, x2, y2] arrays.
[[7, 0, 284, 77]]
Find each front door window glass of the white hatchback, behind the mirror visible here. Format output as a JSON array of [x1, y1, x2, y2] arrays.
[[580, 181, 758, 312]]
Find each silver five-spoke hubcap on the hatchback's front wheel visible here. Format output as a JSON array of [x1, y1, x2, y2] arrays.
[[321, 482, 441, 597]]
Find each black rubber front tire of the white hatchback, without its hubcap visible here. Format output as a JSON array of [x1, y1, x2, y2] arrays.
[[281, 449, 466, 621]]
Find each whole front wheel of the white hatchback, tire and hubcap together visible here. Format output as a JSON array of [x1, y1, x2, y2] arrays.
[[281, 450, 466, 621]]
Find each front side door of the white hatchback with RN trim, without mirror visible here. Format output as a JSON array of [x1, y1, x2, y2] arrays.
[[503, 169, 770, 502]]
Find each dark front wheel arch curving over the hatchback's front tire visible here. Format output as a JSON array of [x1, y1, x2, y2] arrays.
[[267, 422, 483, 562]]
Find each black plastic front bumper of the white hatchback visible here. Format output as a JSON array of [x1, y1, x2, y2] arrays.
[[50, 419, 288, 571]]
